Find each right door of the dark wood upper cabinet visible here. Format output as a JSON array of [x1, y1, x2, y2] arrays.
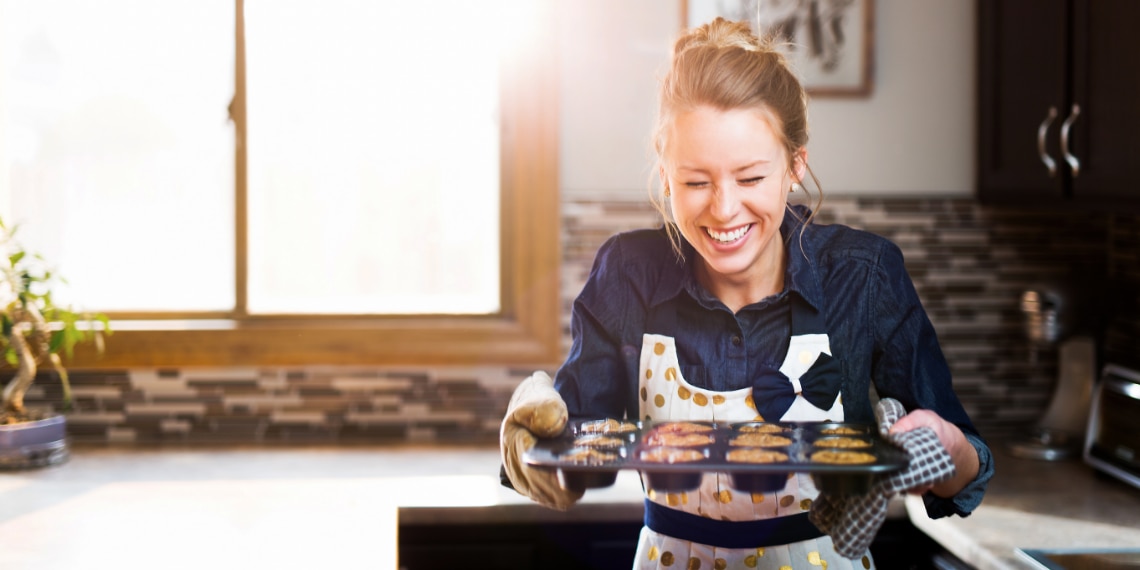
[[1069, 0, 1140, 202]]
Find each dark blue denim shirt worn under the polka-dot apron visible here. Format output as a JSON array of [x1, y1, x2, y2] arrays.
[[555, 206, 993, 518]]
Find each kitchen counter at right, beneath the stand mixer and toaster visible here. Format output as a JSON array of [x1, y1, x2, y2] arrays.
[[906, 443, 1140, 570]]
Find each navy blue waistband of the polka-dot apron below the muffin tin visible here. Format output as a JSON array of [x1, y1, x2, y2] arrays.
[[645, 499, 823, 548]]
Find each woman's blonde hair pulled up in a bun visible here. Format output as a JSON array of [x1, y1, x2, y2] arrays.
[[650, 17, 823, 254]]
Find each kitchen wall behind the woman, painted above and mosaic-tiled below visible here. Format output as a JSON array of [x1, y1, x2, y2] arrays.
[[22, 0, 1140, 445]]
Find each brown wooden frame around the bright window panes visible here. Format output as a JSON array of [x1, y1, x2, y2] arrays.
[[66, 0, 561, 369]]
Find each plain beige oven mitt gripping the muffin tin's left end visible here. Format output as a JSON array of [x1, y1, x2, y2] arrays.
[[499, 371, 584, 511]]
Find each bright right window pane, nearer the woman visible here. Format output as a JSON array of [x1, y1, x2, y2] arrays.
[[245, 0, 503, 315]]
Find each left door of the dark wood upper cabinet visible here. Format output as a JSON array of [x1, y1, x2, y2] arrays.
[[978, 0, 1071, 202]]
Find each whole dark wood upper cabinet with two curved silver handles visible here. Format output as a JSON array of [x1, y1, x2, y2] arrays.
[[978, 0, 1140, 209]]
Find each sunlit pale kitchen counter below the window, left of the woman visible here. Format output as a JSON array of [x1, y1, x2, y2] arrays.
[[0, 446, 642, 570]]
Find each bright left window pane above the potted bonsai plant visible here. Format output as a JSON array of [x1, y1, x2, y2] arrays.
[[0, 0, 235, 312]]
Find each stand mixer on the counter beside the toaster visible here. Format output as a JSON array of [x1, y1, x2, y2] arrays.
[[1010, 287, 1097, 461]]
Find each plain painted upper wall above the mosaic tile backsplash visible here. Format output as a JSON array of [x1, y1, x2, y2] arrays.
[[560, 0, 976, 200]]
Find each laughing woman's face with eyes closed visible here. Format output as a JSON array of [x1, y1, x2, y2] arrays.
[[661, 106, 806, 285]]
